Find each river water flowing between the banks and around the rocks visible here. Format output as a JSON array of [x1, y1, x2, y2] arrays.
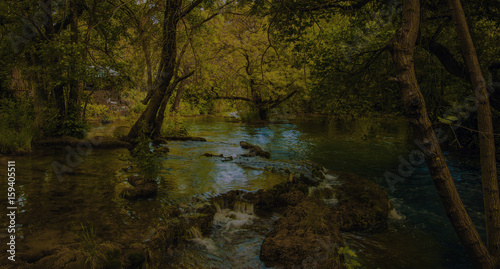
[[0, 114, 485, 268]]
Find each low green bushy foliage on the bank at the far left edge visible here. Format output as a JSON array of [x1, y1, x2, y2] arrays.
[[0, 99, 39, 154]]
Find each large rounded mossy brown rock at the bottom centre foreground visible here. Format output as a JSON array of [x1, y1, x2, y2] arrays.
[[260, 198, 344, 268]]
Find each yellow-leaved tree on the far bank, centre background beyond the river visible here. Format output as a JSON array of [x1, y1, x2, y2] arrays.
[[202, 9, 307, 120]]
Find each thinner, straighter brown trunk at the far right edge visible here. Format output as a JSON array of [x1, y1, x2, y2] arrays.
[[448, 0, 500, 259]]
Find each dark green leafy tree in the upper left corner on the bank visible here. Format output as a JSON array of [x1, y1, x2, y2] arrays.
[[2, 0, 130, 137]]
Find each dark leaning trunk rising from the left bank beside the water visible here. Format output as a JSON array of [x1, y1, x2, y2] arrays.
[[128, 0, 182, 139]]
